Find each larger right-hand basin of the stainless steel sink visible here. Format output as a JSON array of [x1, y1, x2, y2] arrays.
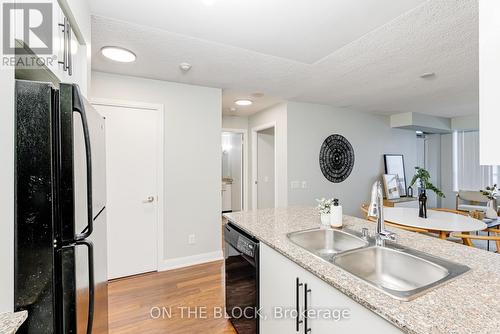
[[333, 246, 469, 300]]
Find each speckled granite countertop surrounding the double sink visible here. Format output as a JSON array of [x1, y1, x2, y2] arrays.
[[224, 208, 500, 334]]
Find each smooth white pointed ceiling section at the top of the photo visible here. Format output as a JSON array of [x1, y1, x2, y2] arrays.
[[91, 0, 425, 64]]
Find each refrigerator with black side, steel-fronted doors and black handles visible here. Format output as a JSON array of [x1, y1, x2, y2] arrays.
[[14, 80, 108, 334]]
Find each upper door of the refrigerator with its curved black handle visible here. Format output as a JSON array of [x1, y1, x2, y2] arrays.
[[60, 84, 106, 242]]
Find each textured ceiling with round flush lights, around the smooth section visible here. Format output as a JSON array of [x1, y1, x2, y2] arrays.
[[92, 0, 478, 117]]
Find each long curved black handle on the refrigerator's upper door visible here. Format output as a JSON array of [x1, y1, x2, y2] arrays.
[[73, 85, 94, 241]]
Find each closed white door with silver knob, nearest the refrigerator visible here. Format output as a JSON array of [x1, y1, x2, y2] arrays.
[[91, 105, 161, 279]]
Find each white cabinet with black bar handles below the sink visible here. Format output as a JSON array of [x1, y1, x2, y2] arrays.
[[260, 243, 401, 334]]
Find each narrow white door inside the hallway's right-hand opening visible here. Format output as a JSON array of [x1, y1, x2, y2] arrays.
[[257, 128, 275, 209]]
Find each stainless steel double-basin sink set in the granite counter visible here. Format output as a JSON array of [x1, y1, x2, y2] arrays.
[[287, 228, 470, 301]]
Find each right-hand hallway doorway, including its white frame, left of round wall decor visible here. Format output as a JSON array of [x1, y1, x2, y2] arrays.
[[252, 124, 276, 209]]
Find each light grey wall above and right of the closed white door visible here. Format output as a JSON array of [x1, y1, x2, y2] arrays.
[[90, 72, 222, 267]]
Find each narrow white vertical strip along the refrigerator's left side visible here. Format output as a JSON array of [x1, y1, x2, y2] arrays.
[[0, 63, 15, 313]]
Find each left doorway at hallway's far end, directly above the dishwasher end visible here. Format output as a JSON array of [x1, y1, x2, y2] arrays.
[[221, 129, 247, 212]]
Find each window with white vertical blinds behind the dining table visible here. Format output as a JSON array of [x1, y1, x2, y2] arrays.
[[453, 131, 500, 191]]
